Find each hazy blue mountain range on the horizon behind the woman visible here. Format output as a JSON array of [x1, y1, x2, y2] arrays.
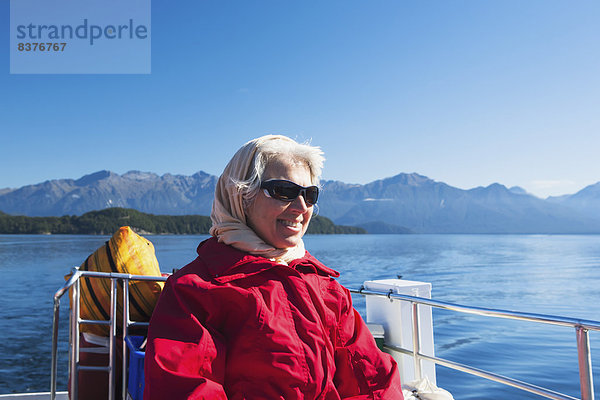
[[0, 171, 600, 233]]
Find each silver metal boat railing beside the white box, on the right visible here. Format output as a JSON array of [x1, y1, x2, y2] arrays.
[[350, 286, 600, 400]]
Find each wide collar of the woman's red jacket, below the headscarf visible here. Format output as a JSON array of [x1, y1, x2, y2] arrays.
[[197, 237, 340, 283]]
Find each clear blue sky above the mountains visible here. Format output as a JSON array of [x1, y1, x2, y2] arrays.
[[0, 0, 600, 197]]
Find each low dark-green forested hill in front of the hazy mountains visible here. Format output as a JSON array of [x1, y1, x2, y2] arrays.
[[0, 207, 367, 235]]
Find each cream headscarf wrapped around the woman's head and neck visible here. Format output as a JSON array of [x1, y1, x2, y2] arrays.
[[210, 135, 305, 264]]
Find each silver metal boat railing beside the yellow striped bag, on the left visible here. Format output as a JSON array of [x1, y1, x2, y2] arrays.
[[50, 268, 167, 400]]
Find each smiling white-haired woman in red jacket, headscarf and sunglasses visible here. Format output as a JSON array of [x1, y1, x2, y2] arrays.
[[144, 135, 402, 400]]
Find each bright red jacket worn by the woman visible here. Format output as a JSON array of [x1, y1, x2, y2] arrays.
[[144, 238, 402, 400]]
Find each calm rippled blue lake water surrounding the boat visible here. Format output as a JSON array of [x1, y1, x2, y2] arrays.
[[0, 235, 600, 400]]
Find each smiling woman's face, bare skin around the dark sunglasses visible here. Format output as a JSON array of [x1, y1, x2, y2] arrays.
[[246, 159, 313, 249]]
